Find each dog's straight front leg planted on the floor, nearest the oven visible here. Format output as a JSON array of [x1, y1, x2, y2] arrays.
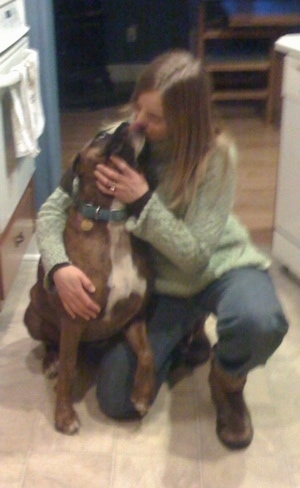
[[55, 319, 82, 435]]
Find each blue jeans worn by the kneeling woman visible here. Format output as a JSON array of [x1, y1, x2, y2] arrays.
[[96, 267, 288, 419]]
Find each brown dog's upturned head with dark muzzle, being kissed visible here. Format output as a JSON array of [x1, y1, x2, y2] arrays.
[[73, 122, 145, 205]]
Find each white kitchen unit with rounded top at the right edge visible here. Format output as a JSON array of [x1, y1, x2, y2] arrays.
[[272, 34, 300, 277]]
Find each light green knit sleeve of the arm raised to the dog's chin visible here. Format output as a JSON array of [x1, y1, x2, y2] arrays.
[[127, 141, 236, 273]]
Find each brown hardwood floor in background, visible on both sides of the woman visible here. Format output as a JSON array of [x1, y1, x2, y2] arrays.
[[61, 104, 280, 249]]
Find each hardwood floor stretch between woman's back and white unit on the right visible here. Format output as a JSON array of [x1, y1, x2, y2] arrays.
[[220, 103, 280, 248]]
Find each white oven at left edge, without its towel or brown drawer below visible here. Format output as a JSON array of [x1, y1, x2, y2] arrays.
[[0, 0, 35, 234]]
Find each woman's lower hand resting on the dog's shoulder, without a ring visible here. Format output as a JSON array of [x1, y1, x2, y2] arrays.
[[53, 265, 100, 320]]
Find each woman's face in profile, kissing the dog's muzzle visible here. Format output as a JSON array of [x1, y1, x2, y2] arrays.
[[131, 90, 167, 142]]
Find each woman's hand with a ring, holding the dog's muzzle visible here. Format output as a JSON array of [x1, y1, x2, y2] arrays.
[[95, 156, 149, 203]]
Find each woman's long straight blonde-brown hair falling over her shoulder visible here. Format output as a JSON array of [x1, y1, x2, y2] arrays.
[[131, 50, 215, 211]]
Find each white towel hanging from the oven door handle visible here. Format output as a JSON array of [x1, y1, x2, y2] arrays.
[[10, 49, 45, 158]]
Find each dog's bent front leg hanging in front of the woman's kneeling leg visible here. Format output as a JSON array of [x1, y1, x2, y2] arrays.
[[124, 320, 155, 415]]
